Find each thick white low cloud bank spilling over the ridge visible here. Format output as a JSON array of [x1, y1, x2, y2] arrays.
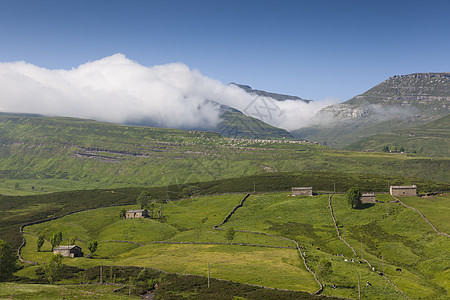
[[0, 54, 336, 130]]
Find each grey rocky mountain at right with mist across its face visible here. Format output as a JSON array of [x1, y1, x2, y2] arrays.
[[291, 73, 450, 148]]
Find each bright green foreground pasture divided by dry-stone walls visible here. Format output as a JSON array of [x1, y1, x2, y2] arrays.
[[18, 193, 450, 299]]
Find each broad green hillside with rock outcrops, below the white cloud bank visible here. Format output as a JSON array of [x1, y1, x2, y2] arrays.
[[0, 114, 450, 195]]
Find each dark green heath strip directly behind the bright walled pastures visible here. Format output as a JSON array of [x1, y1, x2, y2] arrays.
[[0, 172, 449, 251]]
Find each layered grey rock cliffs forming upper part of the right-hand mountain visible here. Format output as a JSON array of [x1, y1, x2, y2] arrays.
[[318, 73, 450, 121]]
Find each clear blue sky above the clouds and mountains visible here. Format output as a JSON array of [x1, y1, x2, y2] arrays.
[[0, 0, 450, 101]]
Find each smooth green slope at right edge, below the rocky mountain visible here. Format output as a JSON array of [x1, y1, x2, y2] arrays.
[[348, 115, 450, 157]]
